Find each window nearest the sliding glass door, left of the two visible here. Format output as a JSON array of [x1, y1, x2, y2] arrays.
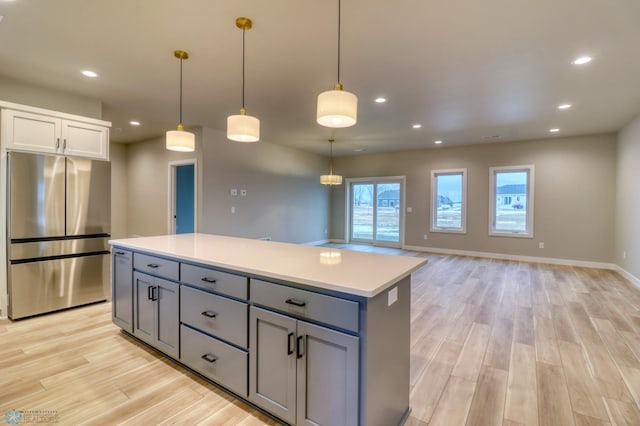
[[431, 169, 467, 233]]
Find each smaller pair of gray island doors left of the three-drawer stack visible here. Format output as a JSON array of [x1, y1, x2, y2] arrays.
[[133, 272, 180, 358]]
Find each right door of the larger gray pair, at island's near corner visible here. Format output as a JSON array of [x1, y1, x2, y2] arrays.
[[296, 321, 359, 426]]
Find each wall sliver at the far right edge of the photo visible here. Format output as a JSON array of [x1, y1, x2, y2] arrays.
[[615, 115, 640, 279]]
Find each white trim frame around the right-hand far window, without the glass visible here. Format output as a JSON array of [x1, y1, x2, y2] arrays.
[[489, 164, 535, 238]]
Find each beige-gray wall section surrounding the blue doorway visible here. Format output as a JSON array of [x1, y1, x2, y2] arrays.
[[126, 128, 203, 237]]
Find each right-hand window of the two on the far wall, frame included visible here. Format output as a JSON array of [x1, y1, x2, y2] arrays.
[[489, 166, 534, 238]]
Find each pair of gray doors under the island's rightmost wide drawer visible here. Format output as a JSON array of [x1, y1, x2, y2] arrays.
[[249, 306, 359, 426]]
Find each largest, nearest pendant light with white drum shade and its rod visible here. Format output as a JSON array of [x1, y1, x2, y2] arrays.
[[316, 0, 358, 128]]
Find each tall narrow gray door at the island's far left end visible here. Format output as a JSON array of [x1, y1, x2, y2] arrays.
[[111, 247, 133, 333]]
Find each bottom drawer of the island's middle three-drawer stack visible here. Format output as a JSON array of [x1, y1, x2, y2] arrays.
[[180, 325, 249, 398]]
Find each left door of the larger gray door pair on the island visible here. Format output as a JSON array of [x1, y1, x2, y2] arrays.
[[249, 306, 296, 424]]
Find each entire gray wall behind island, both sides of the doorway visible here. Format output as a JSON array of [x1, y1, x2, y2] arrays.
[[120, 128, 329, 243]]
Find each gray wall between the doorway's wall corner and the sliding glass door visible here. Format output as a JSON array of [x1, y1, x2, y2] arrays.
[[202, 128, 329, 243]]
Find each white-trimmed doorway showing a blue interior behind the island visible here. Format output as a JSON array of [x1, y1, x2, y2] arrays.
[[169, 160, 197, 234]]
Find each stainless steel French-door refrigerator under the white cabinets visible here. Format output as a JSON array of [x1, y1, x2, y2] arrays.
[[7, 152, 111, 319]]
